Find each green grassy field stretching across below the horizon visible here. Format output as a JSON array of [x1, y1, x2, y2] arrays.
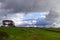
[[0, 27, 60, 40]]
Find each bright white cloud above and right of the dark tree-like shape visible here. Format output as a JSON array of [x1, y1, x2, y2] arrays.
[[6, 13, 24, 25]]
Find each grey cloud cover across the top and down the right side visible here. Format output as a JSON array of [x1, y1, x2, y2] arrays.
[[0, 0, 60, 27]]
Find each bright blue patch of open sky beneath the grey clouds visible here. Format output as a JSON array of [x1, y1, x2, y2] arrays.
[[23, 12, 47, 20]]
